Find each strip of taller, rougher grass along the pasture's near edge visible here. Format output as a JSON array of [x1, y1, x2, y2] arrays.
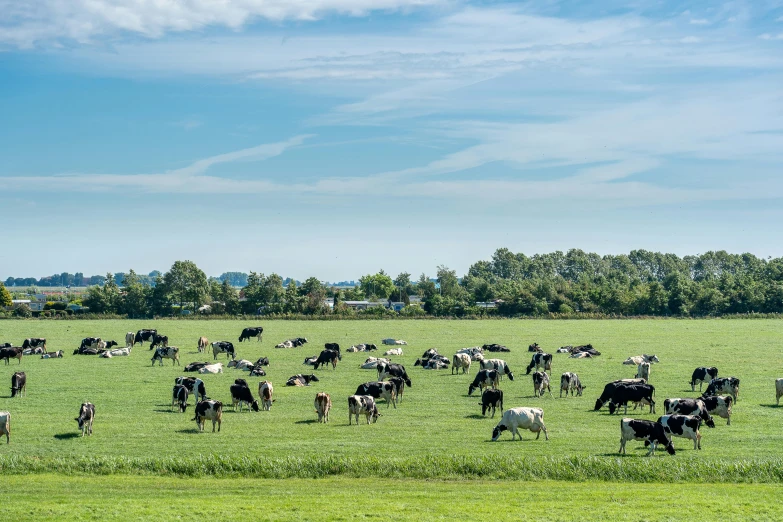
[[0, 455, 783, 483]]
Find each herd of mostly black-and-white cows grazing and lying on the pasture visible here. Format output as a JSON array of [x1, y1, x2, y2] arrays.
[[0, 326, 783, 455]]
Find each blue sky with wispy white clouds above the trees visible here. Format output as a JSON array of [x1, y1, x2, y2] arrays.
[[0, 0, 783, 280]]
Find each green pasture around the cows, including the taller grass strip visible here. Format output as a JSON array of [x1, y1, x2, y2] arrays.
[[0, 320, 783, 476]]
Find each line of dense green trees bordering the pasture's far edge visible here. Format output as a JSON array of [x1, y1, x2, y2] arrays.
[[0, 248, 783, 318]]
